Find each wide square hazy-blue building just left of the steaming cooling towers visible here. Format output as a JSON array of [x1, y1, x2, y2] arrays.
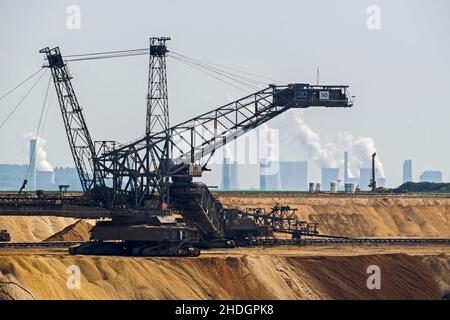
[[280, 161, 308, 191]]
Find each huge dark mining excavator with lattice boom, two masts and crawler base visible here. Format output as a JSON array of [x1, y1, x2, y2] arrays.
[[35, 37, 352, 256]]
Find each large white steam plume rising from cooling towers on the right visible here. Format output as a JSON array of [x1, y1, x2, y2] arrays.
[[280, 110, 385, 178]]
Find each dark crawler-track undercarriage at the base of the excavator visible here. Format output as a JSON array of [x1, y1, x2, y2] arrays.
[[69, 210, 200, 257]]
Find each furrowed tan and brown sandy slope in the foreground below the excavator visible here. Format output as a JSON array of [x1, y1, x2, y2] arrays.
[[0, 252, 449, 299]]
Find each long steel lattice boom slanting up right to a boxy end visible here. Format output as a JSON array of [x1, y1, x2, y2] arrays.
[[97, 84, 352, 207]]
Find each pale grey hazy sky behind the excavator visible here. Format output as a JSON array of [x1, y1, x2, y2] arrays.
[[0, 0, 450, 185]]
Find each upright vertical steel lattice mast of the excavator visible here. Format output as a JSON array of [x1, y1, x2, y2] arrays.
[[146, 37, 170, 135]]
